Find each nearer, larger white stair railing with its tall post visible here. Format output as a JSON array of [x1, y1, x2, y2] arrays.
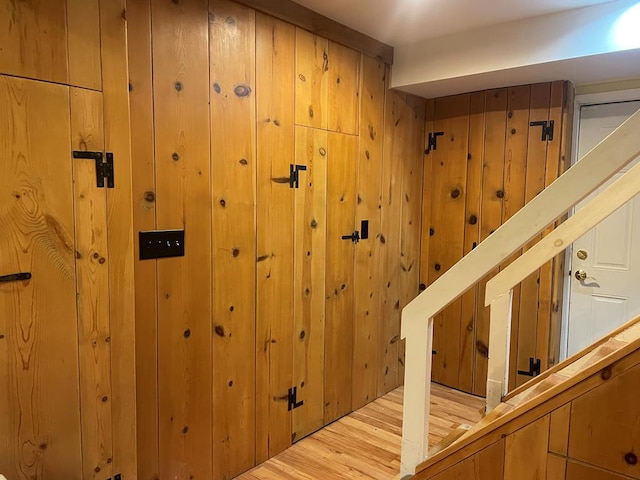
[[400, 107, 640, 478]]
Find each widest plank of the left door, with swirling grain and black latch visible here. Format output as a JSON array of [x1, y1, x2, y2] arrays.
[[0, 76, 82, 480]]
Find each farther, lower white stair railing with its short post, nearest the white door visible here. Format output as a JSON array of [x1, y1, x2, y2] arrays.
[[485, 159, 640, 411]]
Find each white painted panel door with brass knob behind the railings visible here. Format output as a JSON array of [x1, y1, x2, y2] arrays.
[[567, 101, 640, 355]]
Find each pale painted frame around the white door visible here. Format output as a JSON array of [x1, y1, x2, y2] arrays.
[[559, 88, 640, 361]]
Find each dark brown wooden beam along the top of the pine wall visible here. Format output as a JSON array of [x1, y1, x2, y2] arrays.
[[231, 0, 393, 65]]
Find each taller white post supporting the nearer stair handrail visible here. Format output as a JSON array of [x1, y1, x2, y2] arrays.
[[400, 318, 433, 478]]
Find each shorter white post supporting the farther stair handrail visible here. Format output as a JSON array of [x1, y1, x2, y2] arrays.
[[486, 289, 513, 413]]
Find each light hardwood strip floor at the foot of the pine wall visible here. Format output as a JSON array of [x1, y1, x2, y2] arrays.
[[236, 384, 484, 480]]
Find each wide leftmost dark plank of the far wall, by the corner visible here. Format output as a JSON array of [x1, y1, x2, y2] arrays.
[[428, 94, 470, 387]]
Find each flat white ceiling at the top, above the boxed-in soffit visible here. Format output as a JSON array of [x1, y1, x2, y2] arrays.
[[295, 0, 611, 47]]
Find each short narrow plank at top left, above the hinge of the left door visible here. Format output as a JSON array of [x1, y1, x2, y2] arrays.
[[66, 0, 101, 90]]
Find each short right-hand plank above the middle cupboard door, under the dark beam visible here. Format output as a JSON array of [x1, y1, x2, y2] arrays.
[[327, 41, 361, 135]]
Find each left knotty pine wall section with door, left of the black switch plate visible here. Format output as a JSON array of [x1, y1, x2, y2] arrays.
[[0, 0, 137, 479]]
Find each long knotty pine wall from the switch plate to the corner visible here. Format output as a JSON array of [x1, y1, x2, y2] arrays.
[[127, 0, 425, 480]]
